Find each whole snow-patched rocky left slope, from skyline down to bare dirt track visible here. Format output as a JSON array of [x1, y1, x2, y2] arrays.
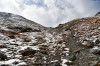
[[0, 13, 69, 66]]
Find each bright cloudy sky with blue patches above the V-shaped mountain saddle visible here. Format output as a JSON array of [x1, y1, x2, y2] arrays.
[[0, 0, 100, 27]]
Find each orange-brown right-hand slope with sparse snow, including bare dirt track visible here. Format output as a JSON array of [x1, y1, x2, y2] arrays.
[[55, 17, 100, 66]]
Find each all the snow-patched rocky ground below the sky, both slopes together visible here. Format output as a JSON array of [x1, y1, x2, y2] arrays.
[[0, 12, 100, 66]]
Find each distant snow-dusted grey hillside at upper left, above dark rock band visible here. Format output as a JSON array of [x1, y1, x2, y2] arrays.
[[0, 12, 45, 32]]
